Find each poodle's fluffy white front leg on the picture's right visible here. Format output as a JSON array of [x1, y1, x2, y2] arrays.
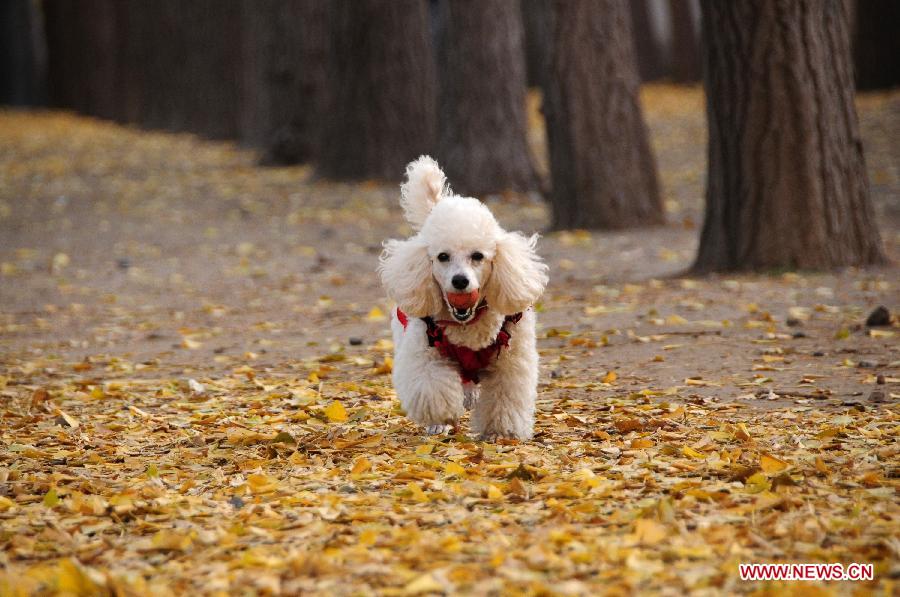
[[472, 312, 538, 441]]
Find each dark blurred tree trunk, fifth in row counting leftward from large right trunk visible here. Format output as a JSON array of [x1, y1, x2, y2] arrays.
[[241, 0, 326, 164]]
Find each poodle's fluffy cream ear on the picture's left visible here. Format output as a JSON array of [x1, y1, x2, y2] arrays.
[[378, 236, 441, 317]]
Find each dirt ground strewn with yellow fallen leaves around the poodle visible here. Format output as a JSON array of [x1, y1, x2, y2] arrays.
[[0, 86, 900, 595]]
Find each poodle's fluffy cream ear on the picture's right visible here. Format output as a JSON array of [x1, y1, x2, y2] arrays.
[[485, 232, 548, 315]]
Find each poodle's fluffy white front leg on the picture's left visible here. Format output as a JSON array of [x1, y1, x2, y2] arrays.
[[394, 321, 463, 435]]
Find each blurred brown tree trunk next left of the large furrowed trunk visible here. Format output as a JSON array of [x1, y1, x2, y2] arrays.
[[544, 0, 664, 229]]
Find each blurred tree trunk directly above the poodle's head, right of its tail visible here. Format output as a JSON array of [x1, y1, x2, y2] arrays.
[[437, 0, 537, 195]]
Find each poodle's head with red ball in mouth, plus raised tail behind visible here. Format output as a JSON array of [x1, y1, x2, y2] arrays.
[[379, 156, 547, 324]]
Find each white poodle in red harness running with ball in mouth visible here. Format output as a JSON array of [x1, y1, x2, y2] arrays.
[[378, 156, 547, 440]]
